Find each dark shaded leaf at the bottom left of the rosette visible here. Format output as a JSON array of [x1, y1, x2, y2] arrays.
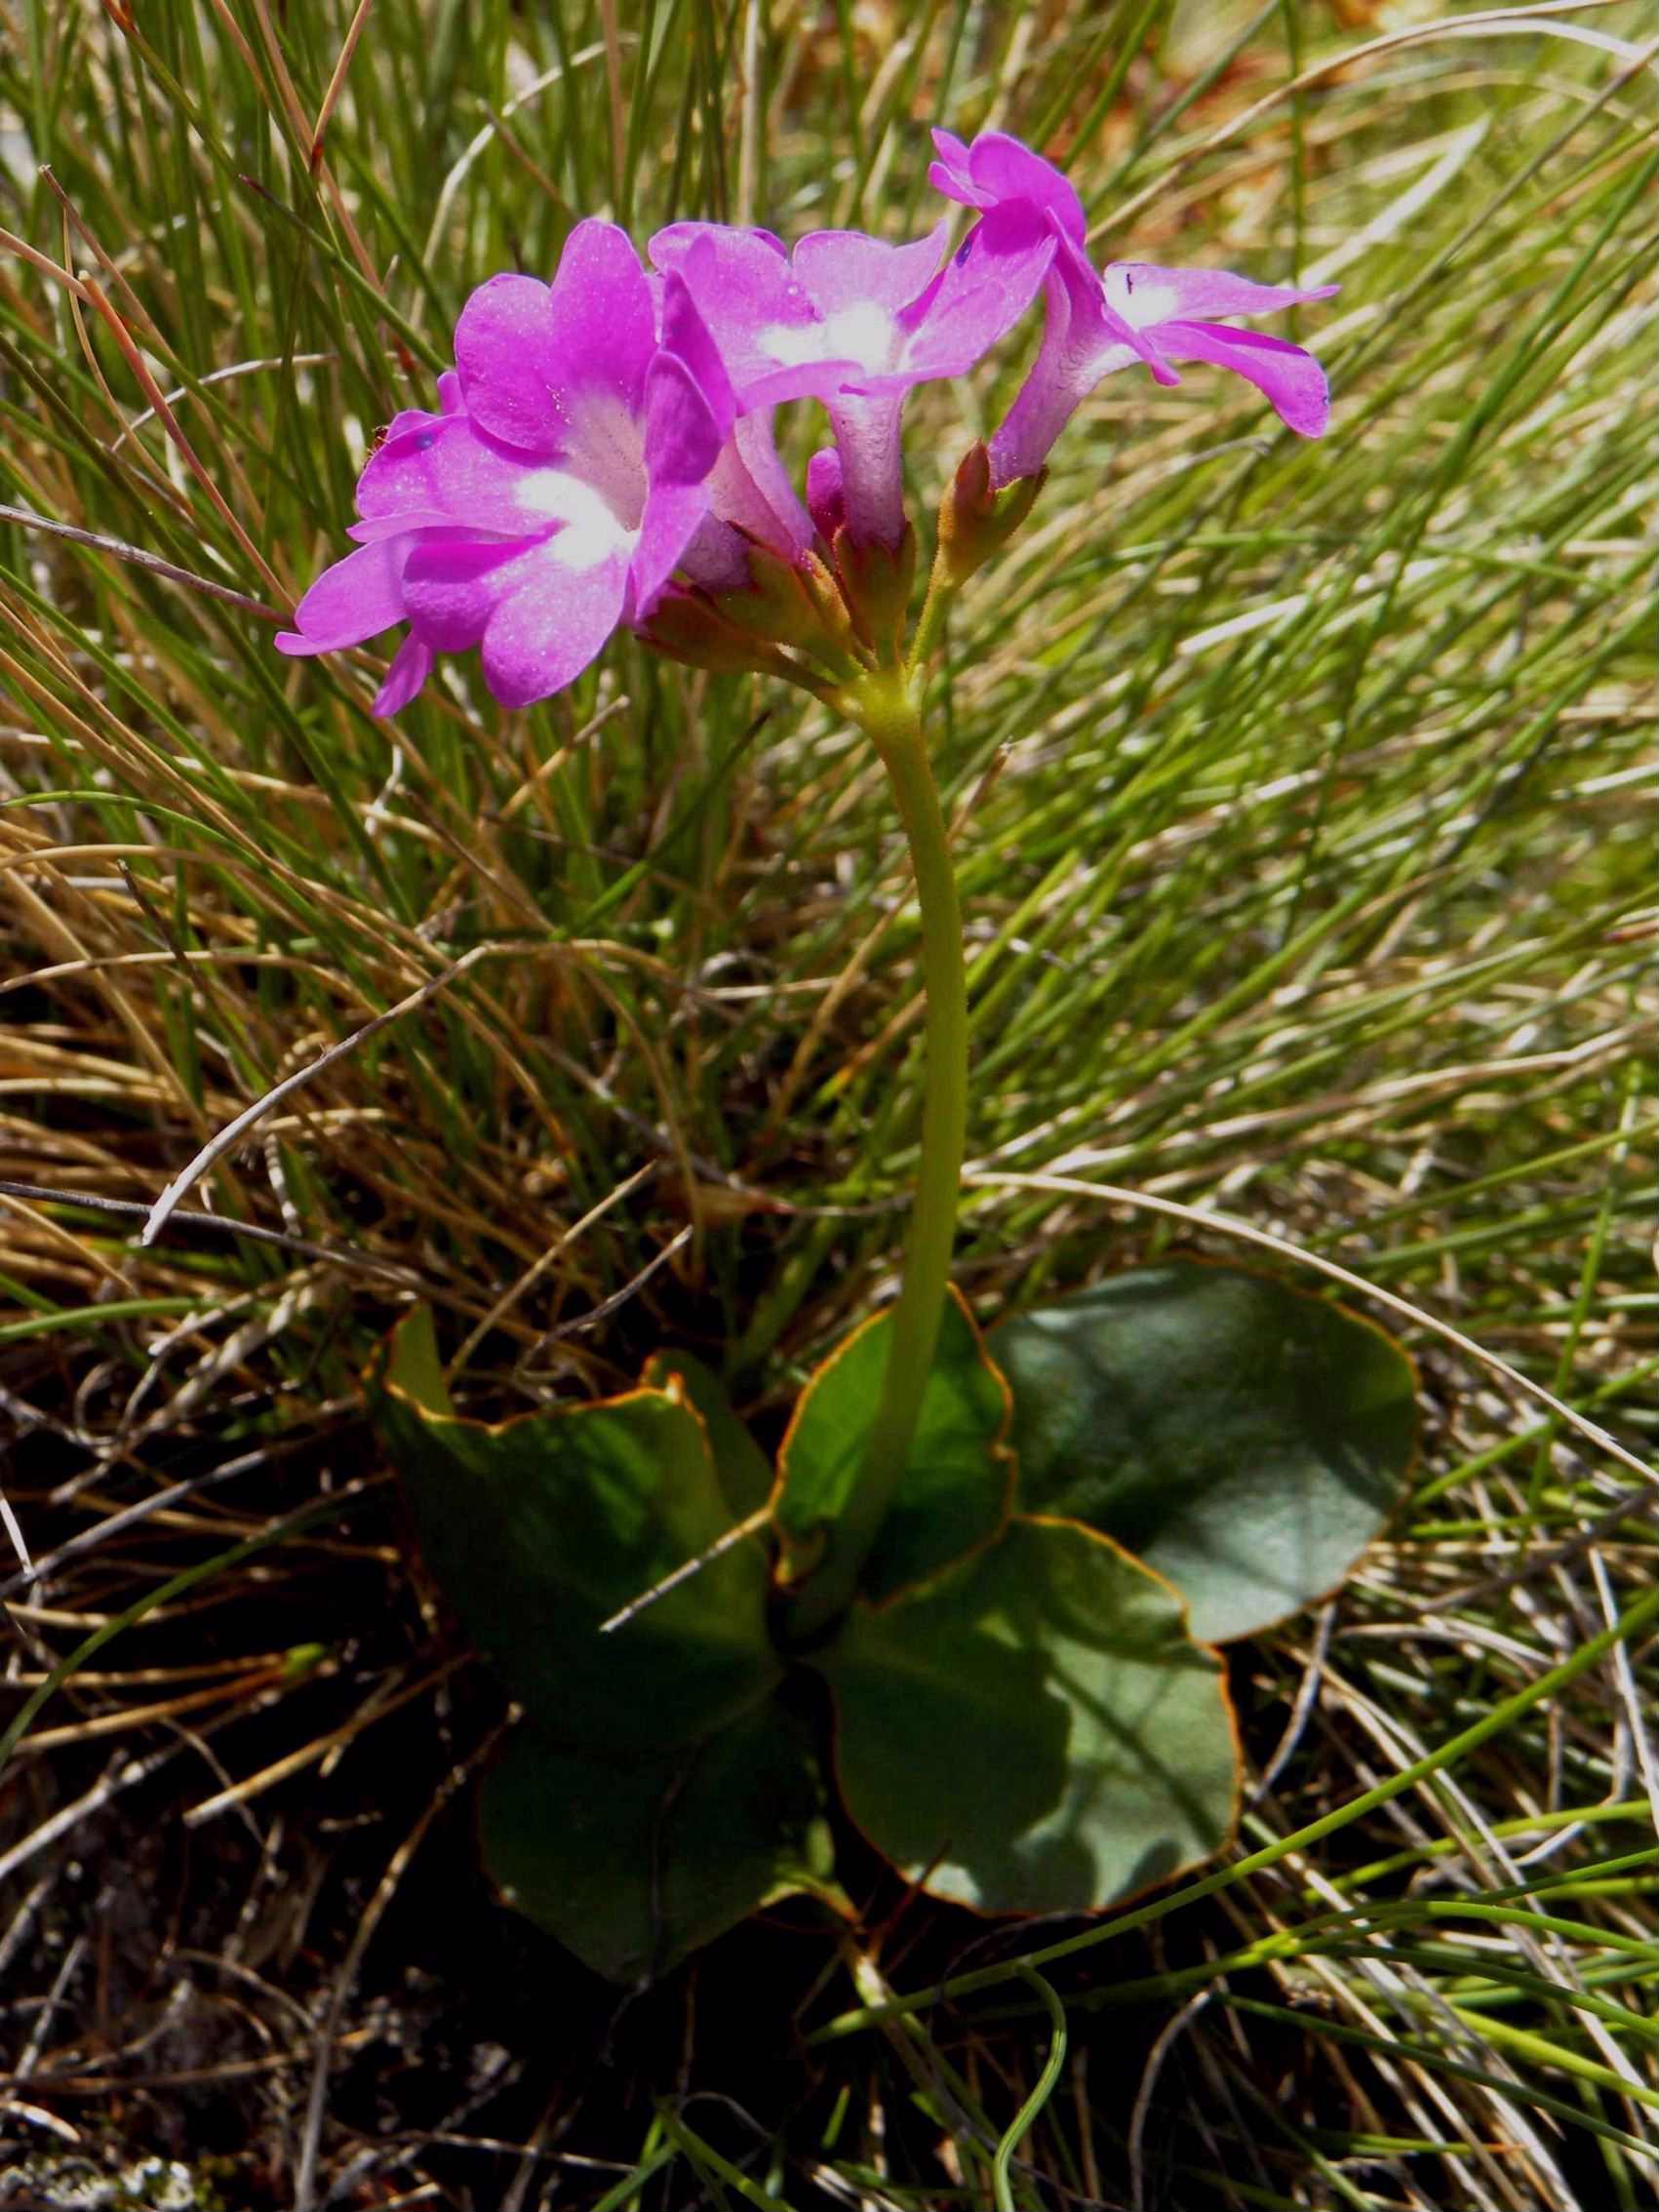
[[480, 1699, 848, 1982]]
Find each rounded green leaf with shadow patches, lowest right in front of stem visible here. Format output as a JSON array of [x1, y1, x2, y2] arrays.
[[814, 1518, 1239, 1914]]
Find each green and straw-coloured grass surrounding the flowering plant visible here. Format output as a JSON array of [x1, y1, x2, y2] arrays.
[[0, 0, 1659, 2212]]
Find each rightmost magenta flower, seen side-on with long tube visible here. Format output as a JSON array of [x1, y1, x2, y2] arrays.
[[929, 131, 1336, 487]]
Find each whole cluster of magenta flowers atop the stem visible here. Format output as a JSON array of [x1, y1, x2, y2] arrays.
[[277, 131, 1334, 715]]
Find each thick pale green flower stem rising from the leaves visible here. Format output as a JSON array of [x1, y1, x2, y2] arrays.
[[796, 670, 968, 1635]]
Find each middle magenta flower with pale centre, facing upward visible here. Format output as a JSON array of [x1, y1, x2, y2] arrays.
[[649, 206, 1055, 546]]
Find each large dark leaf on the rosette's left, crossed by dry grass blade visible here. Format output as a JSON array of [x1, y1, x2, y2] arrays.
[[380, 1325, 781, 1758]]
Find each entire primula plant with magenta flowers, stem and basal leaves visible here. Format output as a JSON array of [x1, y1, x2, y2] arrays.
[[279, 133, 1416, 1980]]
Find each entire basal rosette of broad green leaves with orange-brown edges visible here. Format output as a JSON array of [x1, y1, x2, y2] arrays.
[[382, 1263, 1416, 1980]]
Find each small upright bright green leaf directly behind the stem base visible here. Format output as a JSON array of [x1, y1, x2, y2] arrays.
[[772, 1292, 1013, 1597]]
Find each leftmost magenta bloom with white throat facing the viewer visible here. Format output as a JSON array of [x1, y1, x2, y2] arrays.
[[277, 221, 733, 715]]
